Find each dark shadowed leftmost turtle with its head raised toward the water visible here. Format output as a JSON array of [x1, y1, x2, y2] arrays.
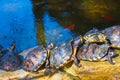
[[0, 43, 21, 71]]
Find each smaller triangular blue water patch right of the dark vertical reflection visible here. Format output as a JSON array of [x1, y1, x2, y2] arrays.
[[42, 11, 74, 44]]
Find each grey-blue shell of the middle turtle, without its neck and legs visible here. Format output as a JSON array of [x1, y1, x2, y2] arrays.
[[50, 41, 72, 68]]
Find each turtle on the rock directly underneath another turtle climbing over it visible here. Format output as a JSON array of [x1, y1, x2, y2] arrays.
[[77, 43, 114, 64]]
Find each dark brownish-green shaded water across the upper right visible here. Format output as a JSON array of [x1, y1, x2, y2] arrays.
[[33, 0, 120, 35]]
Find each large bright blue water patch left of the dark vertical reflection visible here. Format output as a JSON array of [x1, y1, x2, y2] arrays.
[[0, 0, 37, 52]]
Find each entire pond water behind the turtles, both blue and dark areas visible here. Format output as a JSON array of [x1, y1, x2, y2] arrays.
[[0, 0, 120, 52]]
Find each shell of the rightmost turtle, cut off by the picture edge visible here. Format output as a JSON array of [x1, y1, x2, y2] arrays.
[[102, 25, 120, 49]]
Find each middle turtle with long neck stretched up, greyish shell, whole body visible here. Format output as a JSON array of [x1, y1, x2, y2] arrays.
[[44, 36, 81, 75]]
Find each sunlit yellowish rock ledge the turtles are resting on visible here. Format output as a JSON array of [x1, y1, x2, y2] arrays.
[[0, 50, 120, 80]]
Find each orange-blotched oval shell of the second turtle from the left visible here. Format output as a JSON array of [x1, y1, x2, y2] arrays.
[[23, 46, 47, 72]]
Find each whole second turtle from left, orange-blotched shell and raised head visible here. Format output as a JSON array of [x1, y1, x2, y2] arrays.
[[22, 42, 54, 73]]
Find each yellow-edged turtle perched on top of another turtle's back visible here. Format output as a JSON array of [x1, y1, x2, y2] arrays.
[[82, 28, 110, 46]]
